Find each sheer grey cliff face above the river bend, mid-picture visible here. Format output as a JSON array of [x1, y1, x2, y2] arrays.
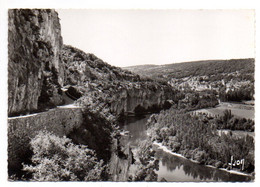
[[110, 82, 172, 114]]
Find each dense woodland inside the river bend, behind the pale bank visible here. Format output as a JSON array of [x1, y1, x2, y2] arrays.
[[147, 108, 254, 172]]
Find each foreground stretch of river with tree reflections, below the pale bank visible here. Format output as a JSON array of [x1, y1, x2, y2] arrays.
[[156, 149, 250, 182]]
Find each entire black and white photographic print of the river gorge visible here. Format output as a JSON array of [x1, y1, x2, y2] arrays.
[[3, 0, 256, 185]]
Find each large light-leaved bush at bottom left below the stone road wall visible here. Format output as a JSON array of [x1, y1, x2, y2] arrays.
[[24, 132, 105, 181]]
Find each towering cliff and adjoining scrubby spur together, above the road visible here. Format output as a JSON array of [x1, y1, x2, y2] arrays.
[[8, 9, 175, 116]]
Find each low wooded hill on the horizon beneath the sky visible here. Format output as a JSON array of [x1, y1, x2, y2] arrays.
[[123, 58, 255, 79]]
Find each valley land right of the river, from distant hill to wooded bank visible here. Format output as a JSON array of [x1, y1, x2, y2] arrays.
[[125, 59, 255, 181]]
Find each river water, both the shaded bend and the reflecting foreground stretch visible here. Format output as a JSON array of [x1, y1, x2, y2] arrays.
[[121, 115, 251, 182]]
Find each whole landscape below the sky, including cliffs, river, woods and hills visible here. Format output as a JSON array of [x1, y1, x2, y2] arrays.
[[8, 9, 255, 182]]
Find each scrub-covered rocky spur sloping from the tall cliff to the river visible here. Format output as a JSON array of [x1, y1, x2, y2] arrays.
[[63, 46, 173, 115]]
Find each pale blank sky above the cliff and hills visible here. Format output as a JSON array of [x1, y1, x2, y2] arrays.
[[57, 9, 255, 67]]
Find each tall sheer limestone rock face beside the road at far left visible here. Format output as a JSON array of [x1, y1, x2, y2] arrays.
[[8, 9, 64, 115]]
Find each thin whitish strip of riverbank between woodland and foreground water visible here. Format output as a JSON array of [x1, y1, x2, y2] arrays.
[[153, 142, 253, 177]]
